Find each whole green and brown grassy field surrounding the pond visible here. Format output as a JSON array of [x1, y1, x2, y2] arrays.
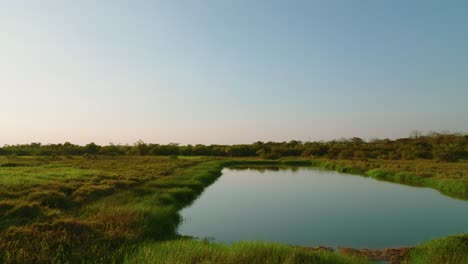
[[0, 155, 468, 263]]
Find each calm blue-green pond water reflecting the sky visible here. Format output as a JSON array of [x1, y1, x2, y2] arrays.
[[179, 168, 468, 248]]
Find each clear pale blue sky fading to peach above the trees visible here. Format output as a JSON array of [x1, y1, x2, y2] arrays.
[[0, 0, 468, 145]]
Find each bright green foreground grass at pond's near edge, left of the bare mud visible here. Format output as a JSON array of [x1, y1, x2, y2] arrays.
[[124, 239, 369, 264]]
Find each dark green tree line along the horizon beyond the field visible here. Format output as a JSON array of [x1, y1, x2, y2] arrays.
[[0, 133, 468, 162]]
